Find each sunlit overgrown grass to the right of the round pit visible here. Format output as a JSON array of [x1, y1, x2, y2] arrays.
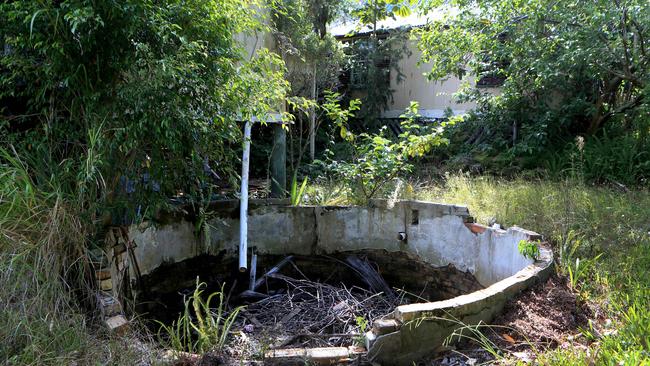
[[416, 175, 650, 365]]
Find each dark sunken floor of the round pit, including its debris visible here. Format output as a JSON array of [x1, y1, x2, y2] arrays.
[[143, 250, 483, 364]]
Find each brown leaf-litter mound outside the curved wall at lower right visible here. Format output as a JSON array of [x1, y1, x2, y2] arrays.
[[420, 276, 591, 366]]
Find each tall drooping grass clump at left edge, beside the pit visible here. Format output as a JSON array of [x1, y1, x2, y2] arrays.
[[0, 151, 146, 365]]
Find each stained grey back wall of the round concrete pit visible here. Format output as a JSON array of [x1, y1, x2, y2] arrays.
[[124, 200, 532, 286]]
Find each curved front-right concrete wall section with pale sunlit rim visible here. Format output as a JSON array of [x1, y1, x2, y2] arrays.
[[366, 243, 553, 365]]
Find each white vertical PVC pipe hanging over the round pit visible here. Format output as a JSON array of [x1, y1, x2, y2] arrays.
[[239, 121, 252, 272]]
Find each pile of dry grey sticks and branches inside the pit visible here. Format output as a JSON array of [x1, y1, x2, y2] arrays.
[[233, 256, 405, 349]]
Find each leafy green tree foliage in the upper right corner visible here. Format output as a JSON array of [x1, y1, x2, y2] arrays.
[[419, 0, 650, 162]]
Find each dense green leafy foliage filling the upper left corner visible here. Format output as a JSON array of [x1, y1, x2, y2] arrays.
[[0, 0, 287, 216]]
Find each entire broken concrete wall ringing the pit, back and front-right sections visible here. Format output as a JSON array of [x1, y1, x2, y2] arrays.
[[102, 200, 552, 364]]
